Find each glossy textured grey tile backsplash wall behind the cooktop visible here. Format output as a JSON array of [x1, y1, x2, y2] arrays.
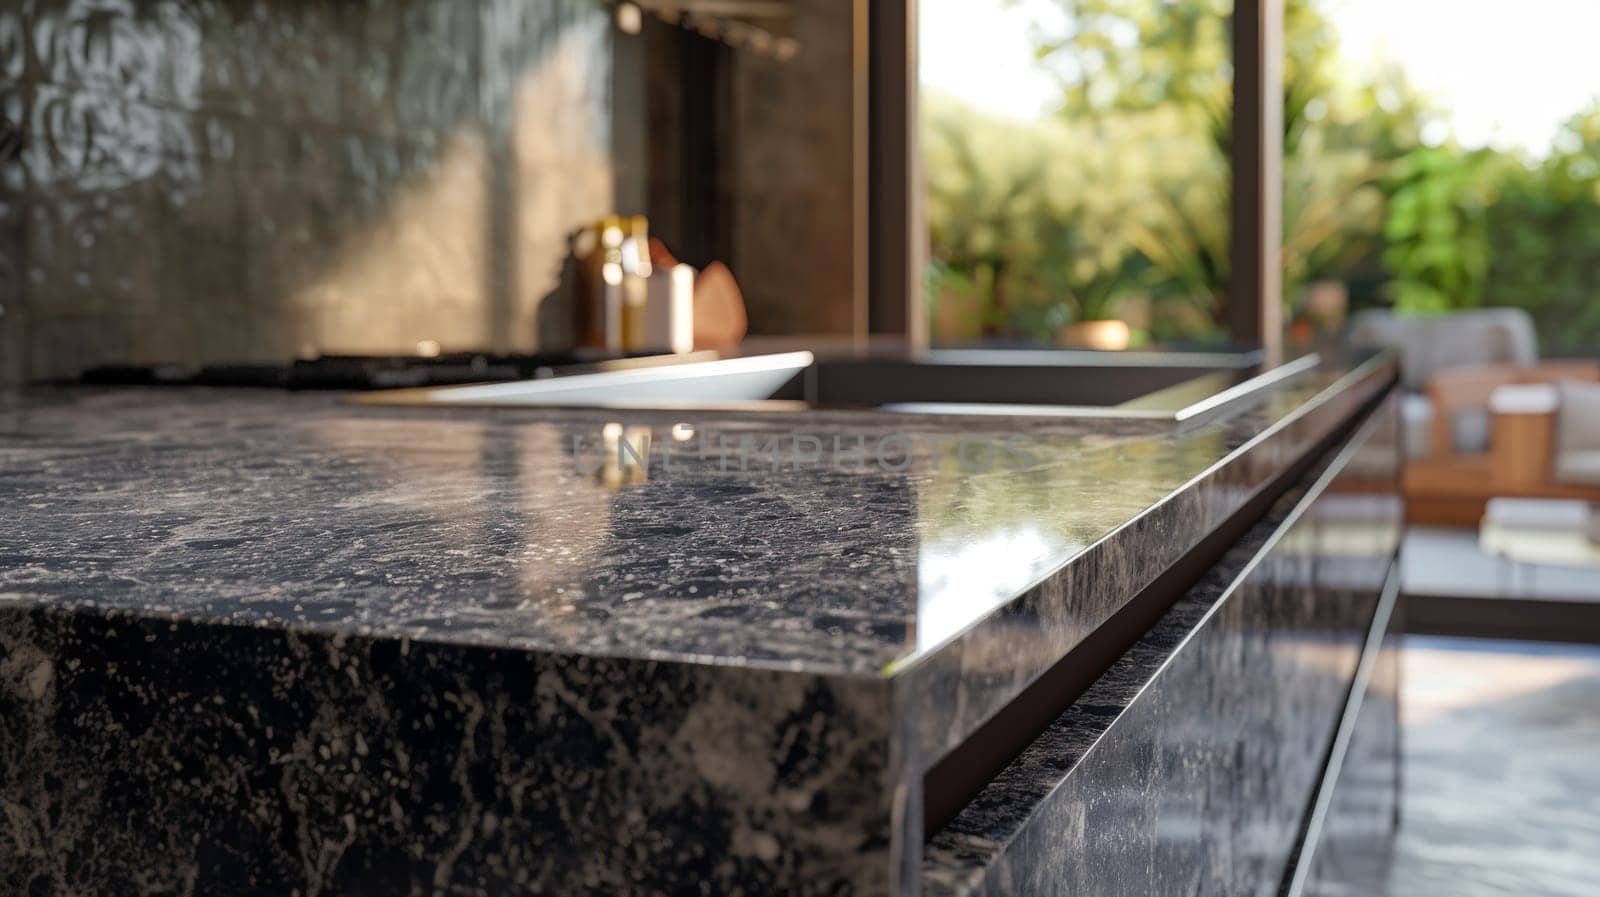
[[0, 0, 620, 382]]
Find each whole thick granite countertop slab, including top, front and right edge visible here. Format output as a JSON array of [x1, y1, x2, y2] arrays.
[[0, 353, 1392, 894]]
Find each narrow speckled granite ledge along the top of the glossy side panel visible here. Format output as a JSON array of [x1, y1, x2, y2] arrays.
[[922, 404, 1381, 895]]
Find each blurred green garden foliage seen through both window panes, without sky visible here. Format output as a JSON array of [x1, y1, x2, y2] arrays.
[[923, 0, 1600, 353]]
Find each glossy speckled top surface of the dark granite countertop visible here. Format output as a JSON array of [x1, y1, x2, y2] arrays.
[[0, 353, 1388, 675]]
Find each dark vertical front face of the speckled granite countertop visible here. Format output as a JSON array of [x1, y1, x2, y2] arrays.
[[0, 609, 890, 897]]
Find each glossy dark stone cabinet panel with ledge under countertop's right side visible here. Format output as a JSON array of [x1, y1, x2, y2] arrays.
[[923, 400, 1400, 897]]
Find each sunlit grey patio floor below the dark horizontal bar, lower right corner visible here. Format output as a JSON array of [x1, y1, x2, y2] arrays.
[[1389, 636, 1600, 897]]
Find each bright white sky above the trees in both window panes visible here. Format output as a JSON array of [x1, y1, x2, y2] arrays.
[[922, 0, 1600, 155]]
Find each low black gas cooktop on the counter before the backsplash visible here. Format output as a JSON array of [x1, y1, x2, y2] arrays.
[[82, 349, 681, 390]]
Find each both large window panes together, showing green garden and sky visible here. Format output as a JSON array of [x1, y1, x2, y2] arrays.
[[922, 0, 1600, 355]]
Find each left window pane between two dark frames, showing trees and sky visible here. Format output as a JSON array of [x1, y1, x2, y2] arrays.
[[922, 0, 1232, 345]]
